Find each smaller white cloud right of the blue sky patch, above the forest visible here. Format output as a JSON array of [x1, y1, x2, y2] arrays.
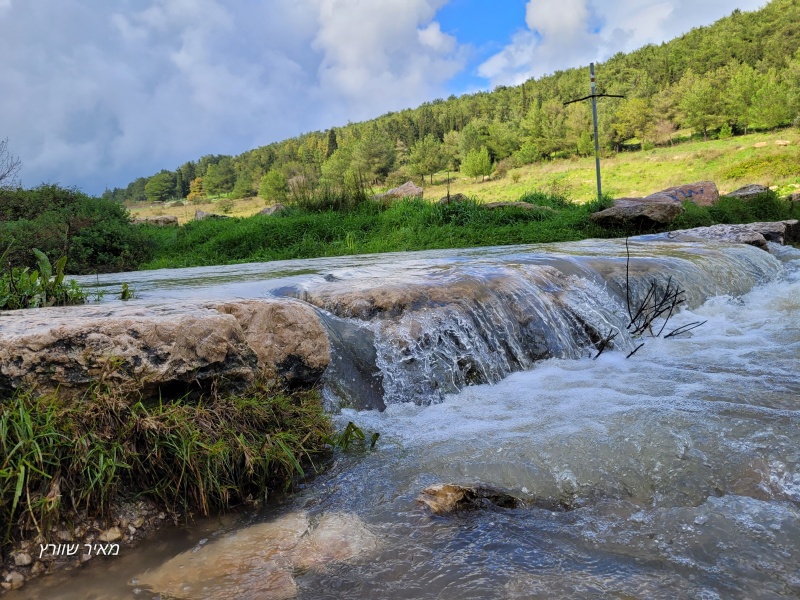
[[478, 0, 766, 85]]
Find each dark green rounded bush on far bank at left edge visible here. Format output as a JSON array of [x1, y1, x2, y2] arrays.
[[0, 184, 155, 274]]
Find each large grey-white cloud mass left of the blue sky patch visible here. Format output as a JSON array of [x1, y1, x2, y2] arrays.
[[0, 0, 463, 193]]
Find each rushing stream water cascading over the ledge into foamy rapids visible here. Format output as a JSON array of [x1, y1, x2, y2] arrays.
[[9, 238, 800, 600]]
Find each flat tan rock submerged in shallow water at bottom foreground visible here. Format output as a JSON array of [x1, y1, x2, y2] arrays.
[[138, 512, 378, 599]]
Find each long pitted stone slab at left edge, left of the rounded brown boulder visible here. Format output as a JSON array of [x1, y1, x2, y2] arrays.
[[0, 306, 258, 397]]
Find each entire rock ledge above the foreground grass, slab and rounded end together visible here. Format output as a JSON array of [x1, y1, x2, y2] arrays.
[[0, 300, 330, 397]]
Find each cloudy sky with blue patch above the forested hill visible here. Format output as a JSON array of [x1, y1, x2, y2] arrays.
[[0, 0, 766, 194]]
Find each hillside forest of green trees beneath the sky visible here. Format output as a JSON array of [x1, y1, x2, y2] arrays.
[[104, 0, 800, 201]]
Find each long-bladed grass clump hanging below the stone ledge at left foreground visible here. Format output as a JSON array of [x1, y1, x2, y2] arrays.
[[0, 383, 332, 545]]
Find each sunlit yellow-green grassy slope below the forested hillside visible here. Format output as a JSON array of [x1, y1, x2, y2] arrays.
[[129, 129, 800, 224]]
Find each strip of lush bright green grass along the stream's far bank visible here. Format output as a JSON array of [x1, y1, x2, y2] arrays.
[[144, 191, 792, 269]]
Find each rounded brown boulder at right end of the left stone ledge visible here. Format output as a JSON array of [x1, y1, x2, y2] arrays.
[[213, 300, 331, 387]]
